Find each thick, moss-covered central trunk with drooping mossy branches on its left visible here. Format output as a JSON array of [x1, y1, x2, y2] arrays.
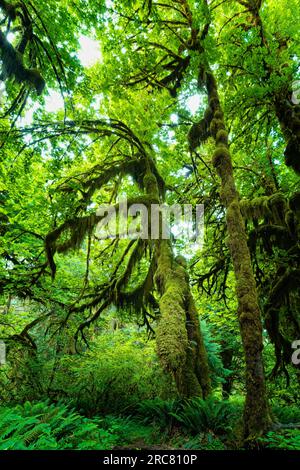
[[144, 164, 211, 398]]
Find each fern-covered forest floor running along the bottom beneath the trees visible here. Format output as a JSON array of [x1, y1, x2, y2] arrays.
[[0, 398, 300, 450]]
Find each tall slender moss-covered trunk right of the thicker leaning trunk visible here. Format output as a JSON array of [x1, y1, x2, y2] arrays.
[[194, 65, 270, 438]]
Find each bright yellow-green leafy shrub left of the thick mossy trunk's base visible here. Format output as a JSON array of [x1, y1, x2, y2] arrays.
[[53, 331, 175, 416]]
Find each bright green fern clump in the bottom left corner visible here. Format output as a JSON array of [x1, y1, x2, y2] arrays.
[[0, 402, 118, 450]]
